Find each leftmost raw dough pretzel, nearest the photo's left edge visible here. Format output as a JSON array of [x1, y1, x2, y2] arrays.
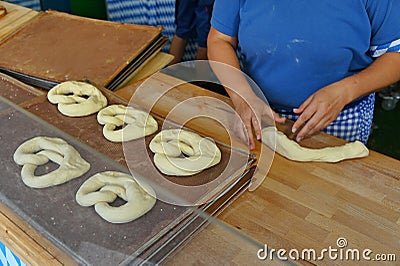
[[13, 136, 90, 188]]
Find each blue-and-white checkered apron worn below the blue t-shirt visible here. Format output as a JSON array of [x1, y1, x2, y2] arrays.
[[278, 93, 375, 144]]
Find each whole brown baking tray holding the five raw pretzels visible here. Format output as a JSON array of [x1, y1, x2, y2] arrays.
[[0, 80, 253, 265]]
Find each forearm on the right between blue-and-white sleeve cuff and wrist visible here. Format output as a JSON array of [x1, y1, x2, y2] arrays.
[[339, 53, 400, 103]]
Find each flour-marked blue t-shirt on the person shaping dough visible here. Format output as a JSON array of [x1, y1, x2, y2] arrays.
[[211, 0, 400, 110]]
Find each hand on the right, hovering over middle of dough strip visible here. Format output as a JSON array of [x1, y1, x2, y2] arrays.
[[292, 83, 349, 142]]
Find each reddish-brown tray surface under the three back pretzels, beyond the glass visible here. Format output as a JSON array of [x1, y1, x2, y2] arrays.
[[22, 87, 254, 204]]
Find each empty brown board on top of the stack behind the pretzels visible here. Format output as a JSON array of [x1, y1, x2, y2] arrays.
[[0, 11, 162, 86]]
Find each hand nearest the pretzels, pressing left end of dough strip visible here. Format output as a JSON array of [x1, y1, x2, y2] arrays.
[[231, 95, 285, 150]]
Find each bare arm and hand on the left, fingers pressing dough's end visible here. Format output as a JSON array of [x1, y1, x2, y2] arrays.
[[207, 27, 285, 149]]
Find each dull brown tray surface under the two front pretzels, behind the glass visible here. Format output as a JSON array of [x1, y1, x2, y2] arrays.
[[0, 100, 190, 265]]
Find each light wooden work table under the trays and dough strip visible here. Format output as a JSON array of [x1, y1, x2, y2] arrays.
[[0, 2, 400, 265]]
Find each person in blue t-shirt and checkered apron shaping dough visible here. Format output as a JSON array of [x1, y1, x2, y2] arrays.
[[208, 0, 400, 148]]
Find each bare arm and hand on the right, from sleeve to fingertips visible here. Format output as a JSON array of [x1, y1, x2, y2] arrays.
[[292, 52, 400, 141]]
